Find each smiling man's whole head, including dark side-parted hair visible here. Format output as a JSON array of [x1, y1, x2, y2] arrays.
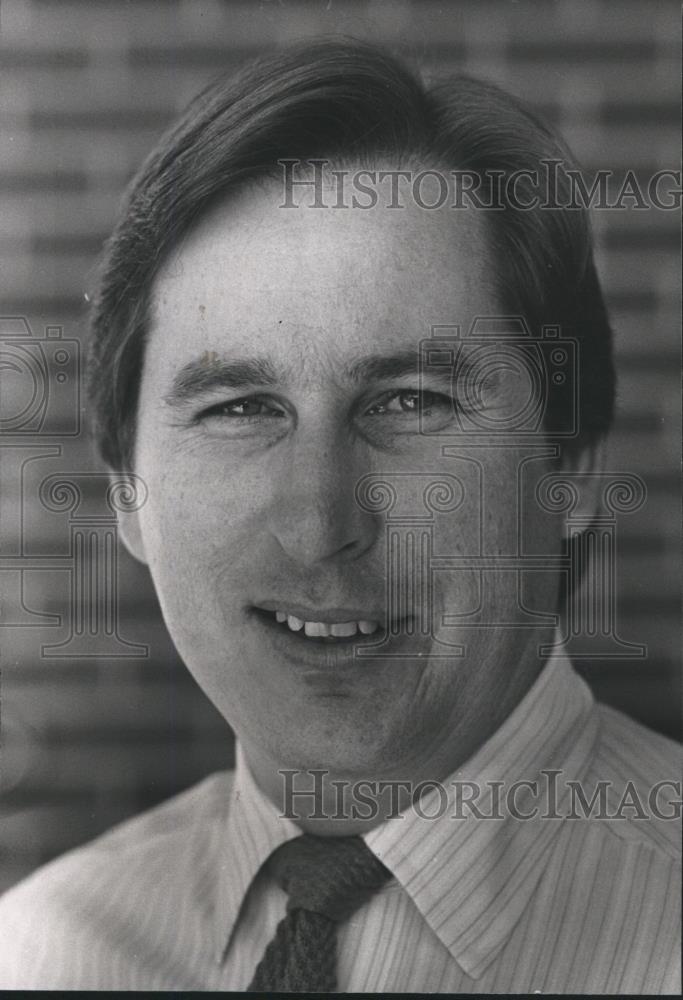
[[90, 37, 613, 804]]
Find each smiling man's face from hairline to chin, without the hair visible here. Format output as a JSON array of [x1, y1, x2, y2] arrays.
[[125, 178, 559, 777]]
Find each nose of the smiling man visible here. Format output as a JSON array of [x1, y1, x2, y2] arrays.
[[269, 429, 380, 567]]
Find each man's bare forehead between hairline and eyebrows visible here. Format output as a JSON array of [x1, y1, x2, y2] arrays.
[[148, 182, 495, 372]]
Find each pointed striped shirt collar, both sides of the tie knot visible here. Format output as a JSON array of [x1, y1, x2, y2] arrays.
[[214, 654, 598, 979]]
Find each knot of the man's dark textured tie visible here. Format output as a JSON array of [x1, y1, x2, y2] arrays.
[[268, 834, 391, 923]]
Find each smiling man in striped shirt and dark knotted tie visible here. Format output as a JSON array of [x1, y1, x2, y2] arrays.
[[0, 43, 680, 993]]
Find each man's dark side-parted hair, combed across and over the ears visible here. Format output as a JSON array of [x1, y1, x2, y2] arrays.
[[88, 41, 614, 469]]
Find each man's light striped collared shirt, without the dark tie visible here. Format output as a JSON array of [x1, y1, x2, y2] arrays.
[[0, 657, 681, 994]]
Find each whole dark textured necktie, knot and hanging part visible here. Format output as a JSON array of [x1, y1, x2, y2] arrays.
[[248, 834, 391, 993]]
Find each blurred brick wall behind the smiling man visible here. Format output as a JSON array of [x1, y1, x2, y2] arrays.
[[0, 0, 680, 889]]
